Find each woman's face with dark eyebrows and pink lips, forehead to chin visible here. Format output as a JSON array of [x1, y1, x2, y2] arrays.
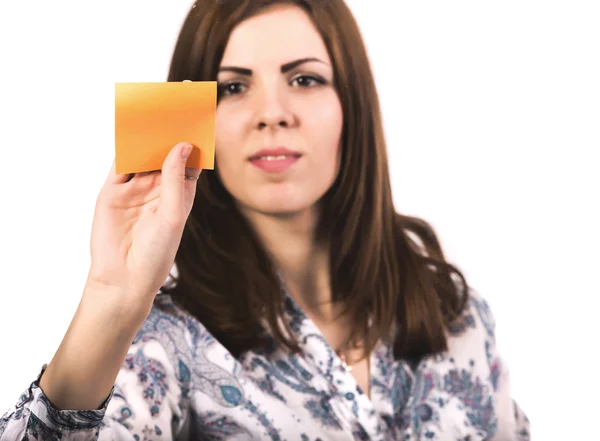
[[215, 6, 343, 215]]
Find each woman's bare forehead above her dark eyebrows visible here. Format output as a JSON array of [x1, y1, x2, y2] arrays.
[[221, 5, 329, 68]]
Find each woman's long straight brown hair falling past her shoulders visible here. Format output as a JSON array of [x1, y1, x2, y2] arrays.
[[162, 0, 468, 360]]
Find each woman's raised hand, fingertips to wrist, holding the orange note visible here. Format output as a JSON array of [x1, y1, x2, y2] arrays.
[[86, 143, 201, 320]]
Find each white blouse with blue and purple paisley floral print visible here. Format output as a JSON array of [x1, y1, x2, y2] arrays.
[[0, 286, 530, 441]]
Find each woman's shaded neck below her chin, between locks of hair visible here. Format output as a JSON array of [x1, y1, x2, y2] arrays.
[[244, 208, 335, 321]]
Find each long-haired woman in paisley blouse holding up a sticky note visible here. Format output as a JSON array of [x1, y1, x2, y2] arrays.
[[0, 0, 529, 441]]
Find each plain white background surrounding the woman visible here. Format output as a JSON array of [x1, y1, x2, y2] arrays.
[[0, 0, 600, 440]]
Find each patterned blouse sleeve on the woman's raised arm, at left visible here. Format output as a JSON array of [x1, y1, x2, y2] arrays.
[[0, 306, 189, 441]]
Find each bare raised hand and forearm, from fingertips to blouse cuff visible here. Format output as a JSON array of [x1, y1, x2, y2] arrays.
[[35, 143, 200, 410]]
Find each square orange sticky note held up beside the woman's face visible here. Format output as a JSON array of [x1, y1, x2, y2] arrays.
[[115, 81, 217, 174]]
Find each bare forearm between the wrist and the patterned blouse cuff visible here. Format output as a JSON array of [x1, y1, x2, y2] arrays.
[[40, 285, 151, 410]]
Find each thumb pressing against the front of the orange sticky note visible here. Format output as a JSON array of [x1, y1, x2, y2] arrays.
[[160, 142, 199, 225]]
